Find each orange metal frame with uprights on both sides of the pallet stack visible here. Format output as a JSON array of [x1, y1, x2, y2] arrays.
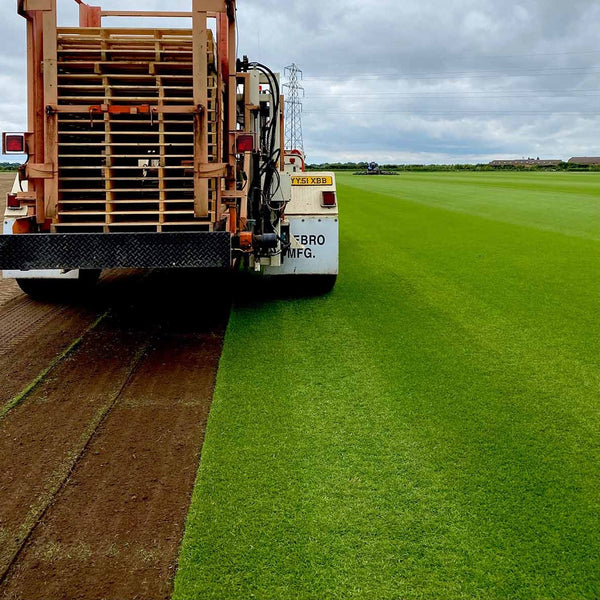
[[18, 0, 237, 227]]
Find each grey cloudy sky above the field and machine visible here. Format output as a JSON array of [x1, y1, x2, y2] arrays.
[[0, 0, 600, 163]]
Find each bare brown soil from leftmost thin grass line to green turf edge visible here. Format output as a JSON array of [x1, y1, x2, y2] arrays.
[[0, 275, 229, 600]]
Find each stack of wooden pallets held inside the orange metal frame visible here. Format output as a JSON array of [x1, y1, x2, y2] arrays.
[[53, 28, 220, 232]]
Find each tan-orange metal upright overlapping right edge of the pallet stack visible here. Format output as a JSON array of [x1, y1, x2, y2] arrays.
[[192, 0, 208, 218]]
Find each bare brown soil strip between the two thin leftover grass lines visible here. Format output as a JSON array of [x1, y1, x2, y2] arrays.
[[0, 325, 149, 578]]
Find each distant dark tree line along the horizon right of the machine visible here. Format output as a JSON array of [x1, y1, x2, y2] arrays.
[[306, 162, 600, 172]]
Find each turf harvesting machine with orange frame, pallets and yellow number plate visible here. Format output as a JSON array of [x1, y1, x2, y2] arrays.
[[0, 0, 338, 295]]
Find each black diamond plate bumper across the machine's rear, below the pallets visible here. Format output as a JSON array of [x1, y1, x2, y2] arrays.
[[0, 231, 231, 271]]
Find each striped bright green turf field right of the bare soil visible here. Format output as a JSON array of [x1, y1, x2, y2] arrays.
[[175, 173, 600, 600]]
